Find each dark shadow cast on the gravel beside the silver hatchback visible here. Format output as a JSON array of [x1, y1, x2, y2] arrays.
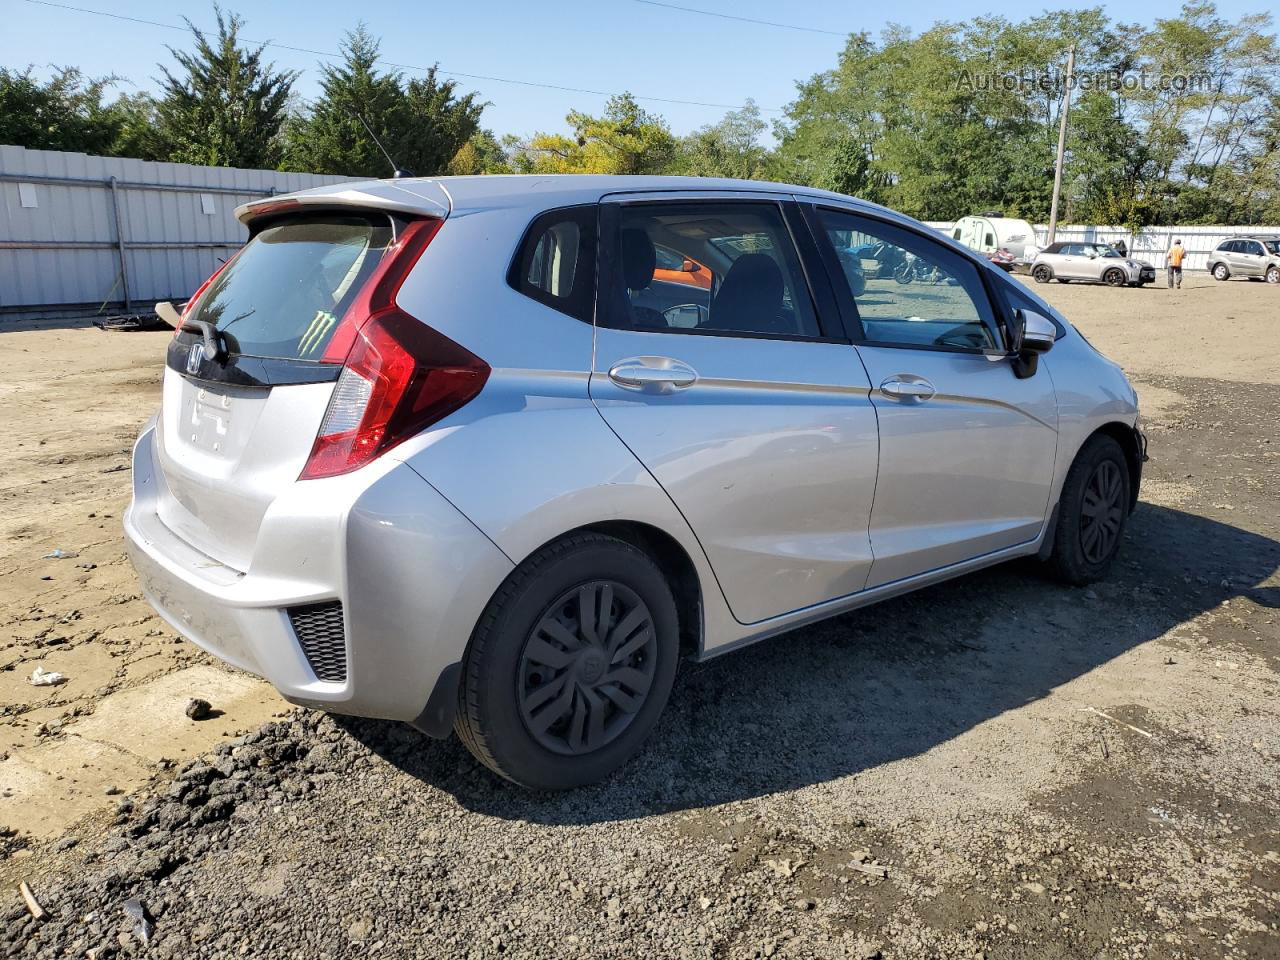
[[340, 504, 1280, 824]]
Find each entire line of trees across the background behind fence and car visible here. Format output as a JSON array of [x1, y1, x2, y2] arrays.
[[0, 3, 1280, 229]]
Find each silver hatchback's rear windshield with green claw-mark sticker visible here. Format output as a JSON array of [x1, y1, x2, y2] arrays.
[[188, 215, 393, 360]]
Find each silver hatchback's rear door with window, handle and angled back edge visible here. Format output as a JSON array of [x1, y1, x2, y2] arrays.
[[590, 193, 892, 632]]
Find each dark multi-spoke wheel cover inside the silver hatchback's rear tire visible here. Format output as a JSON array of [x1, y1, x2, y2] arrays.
[[516, 580, 658, 756]]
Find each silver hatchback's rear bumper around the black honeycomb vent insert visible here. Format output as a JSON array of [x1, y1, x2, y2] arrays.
[[124, 428, 512, 721]]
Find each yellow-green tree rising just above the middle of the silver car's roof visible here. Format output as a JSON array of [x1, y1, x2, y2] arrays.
[[512, 93, 676, 174]]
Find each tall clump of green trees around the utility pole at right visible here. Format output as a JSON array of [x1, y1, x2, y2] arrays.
[[772, 3, 1280, 225]]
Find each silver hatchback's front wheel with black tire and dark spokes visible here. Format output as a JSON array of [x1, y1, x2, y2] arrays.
[[1048, 434, 1130, 586]]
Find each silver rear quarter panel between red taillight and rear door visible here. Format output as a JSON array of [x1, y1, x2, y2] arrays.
[[388, 207, 741, 646]]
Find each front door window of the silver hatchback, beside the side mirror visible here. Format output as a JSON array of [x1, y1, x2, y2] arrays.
[[819, 210, 998, 352]]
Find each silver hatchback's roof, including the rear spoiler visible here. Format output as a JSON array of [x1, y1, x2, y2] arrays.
[[236, 174, 911, 223]]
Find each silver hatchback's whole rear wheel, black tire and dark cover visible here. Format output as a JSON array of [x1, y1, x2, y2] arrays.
[[454, 532, 680, 790]]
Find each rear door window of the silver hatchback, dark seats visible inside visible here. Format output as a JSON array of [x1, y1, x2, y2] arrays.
[[605, 201, 819, 337]]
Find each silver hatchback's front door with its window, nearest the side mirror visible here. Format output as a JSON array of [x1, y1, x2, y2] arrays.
[[806, 205, 1057, 588]]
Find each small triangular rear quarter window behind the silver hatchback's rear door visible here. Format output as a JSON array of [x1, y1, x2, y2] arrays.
[[507, 206, 595, 323]]
